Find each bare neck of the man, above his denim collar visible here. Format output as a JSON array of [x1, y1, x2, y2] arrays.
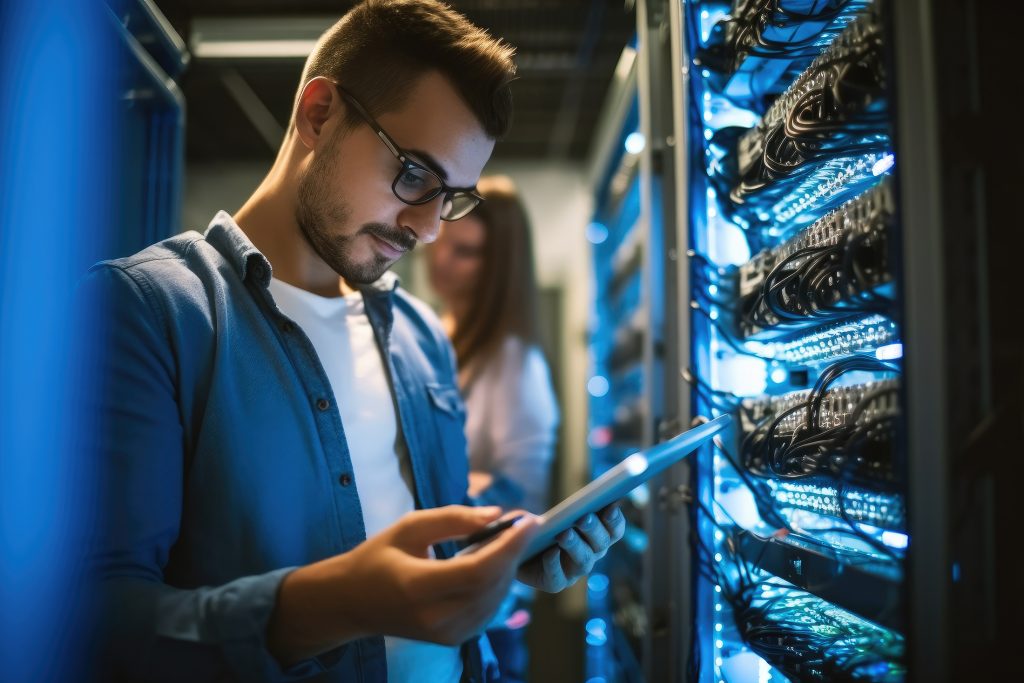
[[234, 170, 353, 297]]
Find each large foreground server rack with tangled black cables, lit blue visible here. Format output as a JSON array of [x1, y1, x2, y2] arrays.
[[589, 0, 1022, 682]]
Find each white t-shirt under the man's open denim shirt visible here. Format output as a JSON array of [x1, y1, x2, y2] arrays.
[[270, 280, 462, 683]]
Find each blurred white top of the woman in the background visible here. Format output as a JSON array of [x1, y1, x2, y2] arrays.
[[465, 337, 558, 514]]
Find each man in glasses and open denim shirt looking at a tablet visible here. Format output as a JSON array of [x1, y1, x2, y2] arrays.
[[83, 0, 625, 681]]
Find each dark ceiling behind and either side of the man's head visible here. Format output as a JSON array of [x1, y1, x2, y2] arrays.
[[156, 0, 635, 163]]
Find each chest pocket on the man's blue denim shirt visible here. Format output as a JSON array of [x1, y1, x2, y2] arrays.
[[427, 383, 469, 505]]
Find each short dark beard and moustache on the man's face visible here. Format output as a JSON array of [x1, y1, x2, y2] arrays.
[[295, 140, 416, 285]]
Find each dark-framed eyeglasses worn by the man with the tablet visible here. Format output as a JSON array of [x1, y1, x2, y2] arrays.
[[337, 85, 483, 221]]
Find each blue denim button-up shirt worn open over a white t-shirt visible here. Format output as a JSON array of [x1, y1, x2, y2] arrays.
[[80, 212, 494, 682]]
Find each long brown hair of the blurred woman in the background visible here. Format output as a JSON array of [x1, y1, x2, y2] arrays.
[[452, 175, 539, 382]]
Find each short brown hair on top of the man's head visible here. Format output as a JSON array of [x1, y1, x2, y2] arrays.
[[293, 0, 516, 139]]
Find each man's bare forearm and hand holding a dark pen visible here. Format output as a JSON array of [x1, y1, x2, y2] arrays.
[[268, 506, 537, 665]]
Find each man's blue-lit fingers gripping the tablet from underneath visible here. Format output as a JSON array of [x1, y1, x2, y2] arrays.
[[517, 505, 626, 593]]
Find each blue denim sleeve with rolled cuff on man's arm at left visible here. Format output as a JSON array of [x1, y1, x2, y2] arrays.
[[79, 265, 336, 681]]
